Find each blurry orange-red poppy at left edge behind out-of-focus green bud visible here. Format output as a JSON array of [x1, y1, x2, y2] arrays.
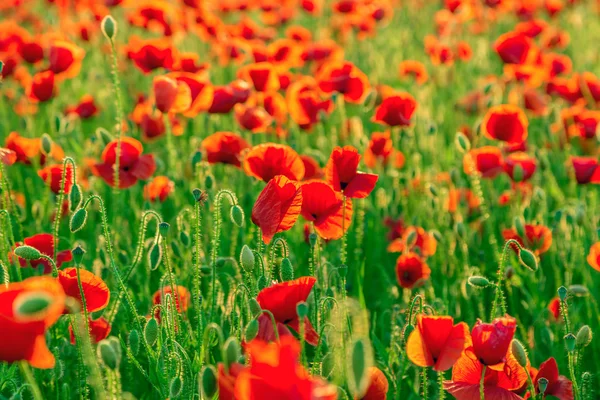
[[0, 277, 65, 369]]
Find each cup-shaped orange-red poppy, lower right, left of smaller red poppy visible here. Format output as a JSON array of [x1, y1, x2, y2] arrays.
[[406, 314, 470, 371]]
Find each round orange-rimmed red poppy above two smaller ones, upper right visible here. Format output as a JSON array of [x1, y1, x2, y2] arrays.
[[481, 104, 529, 144]]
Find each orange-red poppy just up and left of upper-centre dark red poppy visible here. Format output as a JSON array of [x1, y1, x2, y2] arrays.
[[316, 61, 371, 104]]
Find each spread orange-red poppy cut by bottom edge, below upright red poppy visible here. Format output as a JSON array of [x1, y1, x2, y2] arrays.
[[444, 351, 527, 400]]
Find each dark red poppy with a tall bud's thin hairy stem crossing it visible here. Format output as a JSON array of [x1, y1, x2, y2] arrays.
[[92, 137, 156, 189]]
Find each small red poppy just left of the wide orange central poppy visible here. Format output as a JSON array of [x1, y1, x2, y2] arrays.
[[202, 132, 250, 168]]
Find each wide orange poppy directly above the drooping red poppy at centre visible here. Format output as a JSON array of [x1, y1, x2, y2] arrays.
[[243, 143, 304, 182]]
